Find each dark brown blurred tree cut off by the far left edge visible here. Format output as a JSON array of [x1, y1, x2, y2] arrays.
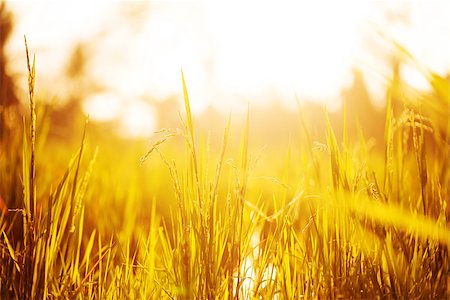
[[0, 1, 19, 139]]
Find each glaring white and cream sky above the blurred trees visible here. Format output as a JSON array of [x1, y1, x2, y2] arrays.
[[8, 0, 450, 135]]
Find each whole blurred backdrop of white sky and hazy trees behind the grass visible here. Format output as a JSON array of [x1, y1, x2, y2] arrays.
[[0, 1, 450, 139]]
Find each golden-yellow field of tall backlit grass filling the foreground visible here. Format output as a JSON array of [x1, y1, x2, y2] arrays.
[[0, 40, 450, 299]]
